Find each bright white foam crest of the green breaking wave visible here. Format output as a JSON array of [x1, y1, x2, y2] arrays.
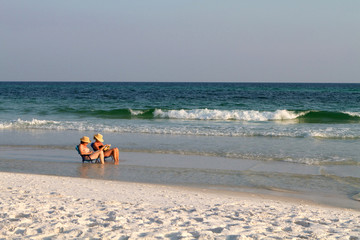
[[154, 108, 304, 121]]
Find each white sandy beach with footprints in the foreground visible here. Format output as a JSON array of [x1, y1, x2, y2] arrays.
[[0, 173, 360, 240]]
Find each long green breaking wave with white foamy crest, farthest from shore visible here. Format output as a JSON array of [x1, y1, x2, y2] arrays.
[[50, 108, 360, 124]]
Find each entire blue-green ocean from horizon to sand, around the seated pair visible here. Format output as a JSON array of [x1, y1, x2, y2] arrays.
[[0, 82, 360, 209]]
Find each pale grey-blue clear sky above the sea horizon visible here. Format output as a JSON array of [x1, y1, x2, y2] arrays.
[[0, 0, 360, 83]]
